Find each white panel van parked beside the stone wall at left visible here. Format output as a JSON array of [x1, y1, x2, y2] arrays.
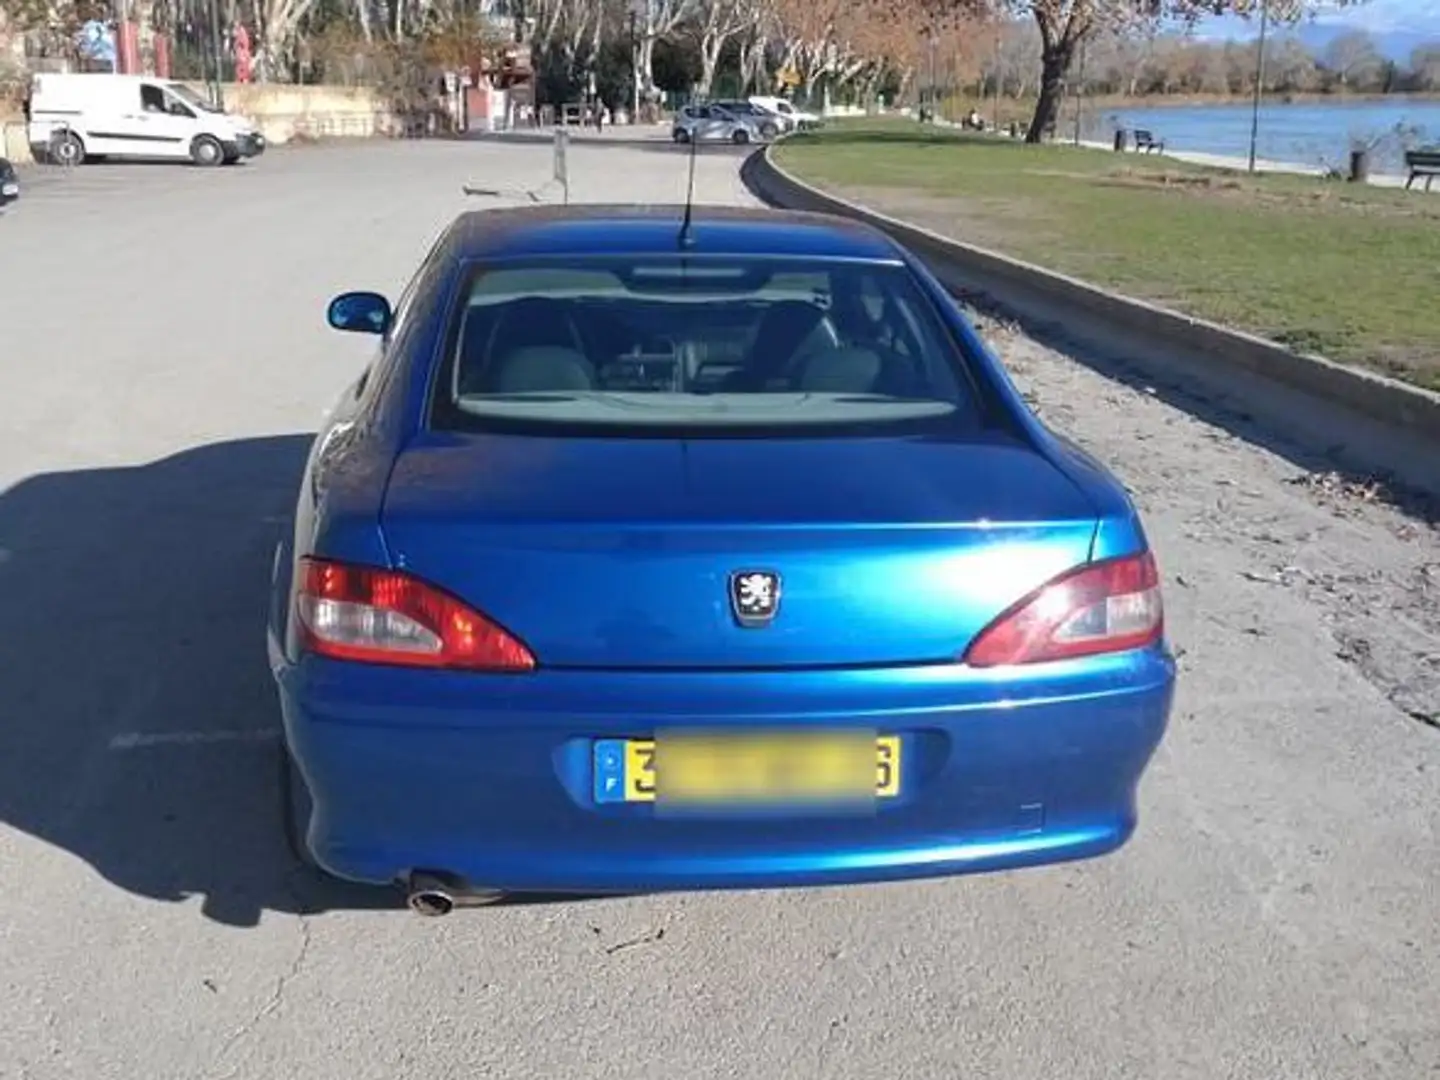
[[26, 73, 265, 166]]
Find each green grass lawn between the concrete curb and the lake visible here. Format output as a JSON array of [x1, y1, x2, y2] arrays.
[[776, 120, 1440, 390]]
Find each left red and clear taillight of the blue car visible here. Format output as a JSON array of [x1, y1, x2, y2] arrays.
[[295, 557, 536, 671]]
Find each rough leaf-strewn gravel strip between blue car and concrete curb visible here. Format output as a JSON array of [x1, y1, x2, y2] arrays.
[[971, 310, 1440, 729]]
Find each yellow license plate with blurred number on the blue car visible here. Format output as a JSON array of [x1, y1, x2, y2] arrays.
[[605, 733, 900, 804]]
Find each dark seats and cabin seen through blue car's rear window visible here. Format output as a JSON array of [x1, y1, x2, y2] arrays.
[[451, 266, 959, 402]]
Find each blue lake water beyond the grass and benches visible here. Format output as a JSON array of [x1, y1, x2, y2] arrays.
[[1082, 101, 1440, 173]]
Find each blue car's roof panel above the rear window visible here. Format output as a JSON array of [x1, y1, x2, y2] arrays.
[[448, 203, 900, 262]]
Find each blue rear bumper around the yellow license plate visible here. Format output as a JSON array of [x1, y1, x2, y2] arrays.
[[275, 651, 1174, 893]]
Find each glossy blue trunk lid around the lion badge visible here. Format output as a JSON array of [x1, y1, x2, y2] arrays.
[[382, 433, 1096, 670]]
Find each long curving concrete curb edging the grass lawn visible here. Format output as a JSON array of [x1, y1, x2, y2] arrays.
[[746, 140, 1440, 461]]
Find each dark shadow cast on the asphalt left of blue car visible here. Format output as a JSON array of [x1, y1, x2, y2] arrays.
[[0, 433, 627, 927]]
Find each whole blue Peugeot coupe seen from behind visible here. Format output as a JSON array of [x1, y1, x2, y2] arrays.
[[268, 206, 1175, 914]]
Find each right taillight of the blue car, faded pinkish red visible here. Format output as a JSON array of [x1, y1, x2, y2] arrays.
[[965, 552, 1165, 668]]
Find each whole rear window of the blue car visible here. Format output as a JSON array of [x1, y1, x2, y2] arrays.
[[431, 252, 979, 438]]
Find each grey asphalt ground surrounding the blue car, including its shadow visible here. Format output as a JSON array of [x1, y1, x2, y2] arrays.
[[0, 143, 1440, 1080]]
